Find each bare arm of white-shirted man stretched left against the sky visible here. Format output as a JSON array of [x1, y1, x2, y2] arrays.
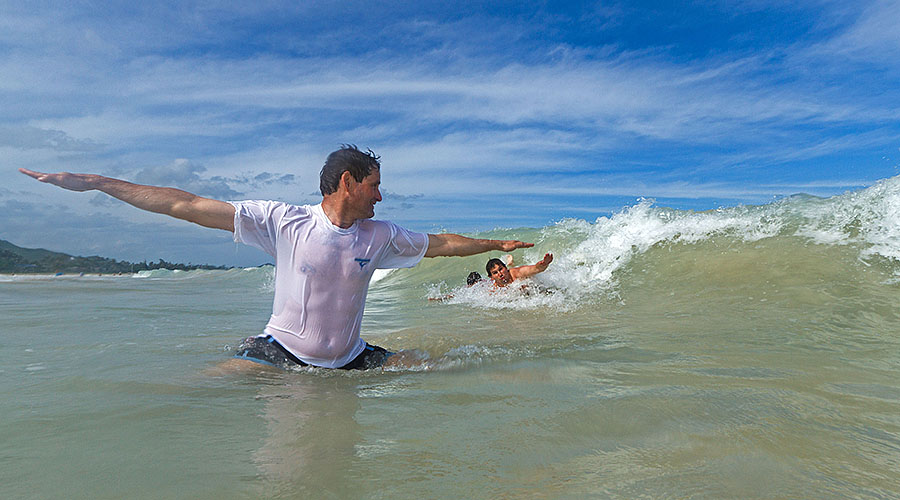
[[19, 168, 234, 232]]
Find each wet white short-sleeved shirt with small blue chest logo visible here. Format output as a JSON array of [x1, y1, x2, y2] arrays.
[[229, 201, 428, 368]]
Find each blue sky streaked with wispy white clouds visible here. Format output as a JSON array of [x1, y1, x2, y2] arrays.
[[0, 0, 900, 266]]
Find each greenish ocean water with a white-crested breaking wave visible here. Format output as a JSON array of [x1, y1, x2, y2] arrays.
[[0, 178, 900, 499]]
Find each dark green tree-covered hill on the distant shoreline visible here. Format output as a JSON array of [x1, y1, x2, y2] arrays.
[[0, 240, 227, 274]]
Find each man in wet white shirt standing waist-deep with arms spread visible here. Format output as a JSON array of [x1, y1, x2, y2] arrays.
[[19, 146, 533, 369]]
